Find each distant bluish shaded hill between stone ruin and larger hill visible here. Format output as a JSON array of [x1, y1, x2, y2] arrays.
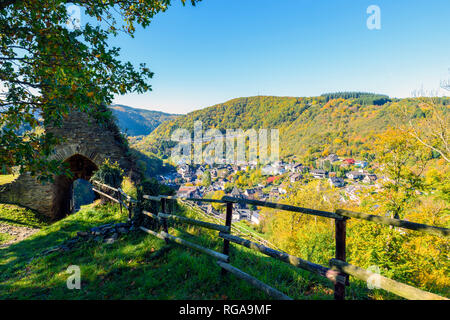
[[109, 104, 178, 136]]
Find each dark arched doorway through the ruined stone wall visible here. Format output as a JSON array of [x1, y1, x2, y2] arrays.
[[53, 154, 98, 219]]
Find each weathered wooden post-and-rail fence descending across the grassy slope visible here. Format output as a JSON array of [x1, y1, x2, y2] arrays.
[[94, 182, 450, 300]]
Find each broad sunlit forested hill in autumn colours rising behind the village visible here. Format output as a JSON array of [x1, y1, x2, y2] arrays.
[[134, 93, 448, 158]]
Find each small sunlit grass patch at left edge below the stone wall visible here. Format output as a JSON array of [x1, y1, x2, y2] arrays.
[[0, 203, 49, 228]]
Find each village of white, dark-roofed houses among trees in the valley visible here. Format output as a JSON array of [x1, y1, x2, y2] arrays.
[[158, 154, 386, 225]]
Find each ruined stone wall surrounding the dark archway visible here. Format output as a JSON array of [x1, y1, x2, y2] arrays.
[[0, 112, 133, 219]]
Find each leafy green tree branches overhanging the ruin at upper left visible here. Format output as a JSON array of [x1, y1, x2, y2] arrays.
[[0, 0, 198, 180]]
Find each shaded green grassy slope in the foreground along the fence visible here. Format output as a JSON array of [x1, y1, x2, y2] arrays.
[[0, 201, 378, 299]]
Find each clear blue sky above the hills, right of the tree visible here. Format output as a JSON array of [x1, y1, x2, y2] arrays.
[[102, 0, 450, 113]]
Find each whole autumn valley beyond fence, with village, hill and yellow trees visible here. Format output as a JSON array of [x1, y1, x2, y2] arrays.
[[114, 93, 450, 295]]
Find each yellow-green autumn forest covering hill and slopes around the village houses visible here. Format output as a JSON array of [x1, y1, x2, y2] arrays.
[[128, 93, 450, 296]]
